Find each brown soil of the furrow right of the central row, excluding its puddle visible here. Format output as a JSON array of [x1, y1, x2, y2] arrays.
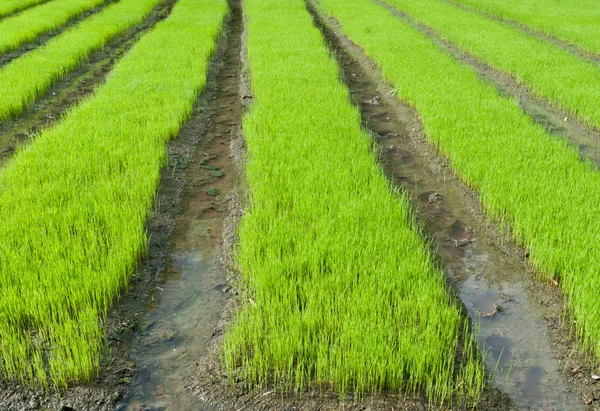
[[308, 0, 600, 409]]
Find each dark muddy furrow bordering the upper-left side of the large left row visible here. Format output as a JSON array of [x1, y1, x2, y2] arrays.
[[0, 0, 176, 167]]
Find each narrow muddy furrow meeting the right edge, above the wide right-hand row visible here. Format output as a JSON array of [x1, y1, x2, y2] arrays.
[[373, 0, 600, 171]]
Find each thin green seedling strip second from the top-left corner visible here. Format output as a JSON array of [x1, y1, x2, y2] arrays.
[[0, 0, 106, 54]]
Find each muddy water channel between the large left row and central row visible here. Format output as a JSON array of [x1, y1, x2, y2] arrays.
[[120, 1, 243, 411]]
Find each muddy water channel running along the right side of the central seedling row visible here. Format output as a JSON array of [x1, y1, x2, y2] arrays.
[[309, 7, 583, 411]]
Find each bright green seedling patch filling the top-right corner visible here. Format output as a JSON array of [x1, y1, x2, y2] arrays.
[[453, 0, 600, 54]]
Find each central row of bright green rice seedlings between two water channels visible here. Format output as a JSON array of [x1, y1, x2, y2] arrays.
[[224, 0, 484, 402]]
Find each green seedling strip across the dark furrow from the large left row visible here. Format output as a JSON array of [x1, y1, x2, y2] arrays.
[[0, 0, 163, 120]]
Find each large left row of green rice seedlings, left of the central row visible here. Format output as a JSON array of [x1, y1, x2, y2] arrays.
[[0, 0, 227, 386]]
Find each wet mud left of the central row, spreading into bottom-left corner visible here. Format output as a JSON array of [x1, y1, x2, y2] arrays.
[[0, 2, 236, 411]]
